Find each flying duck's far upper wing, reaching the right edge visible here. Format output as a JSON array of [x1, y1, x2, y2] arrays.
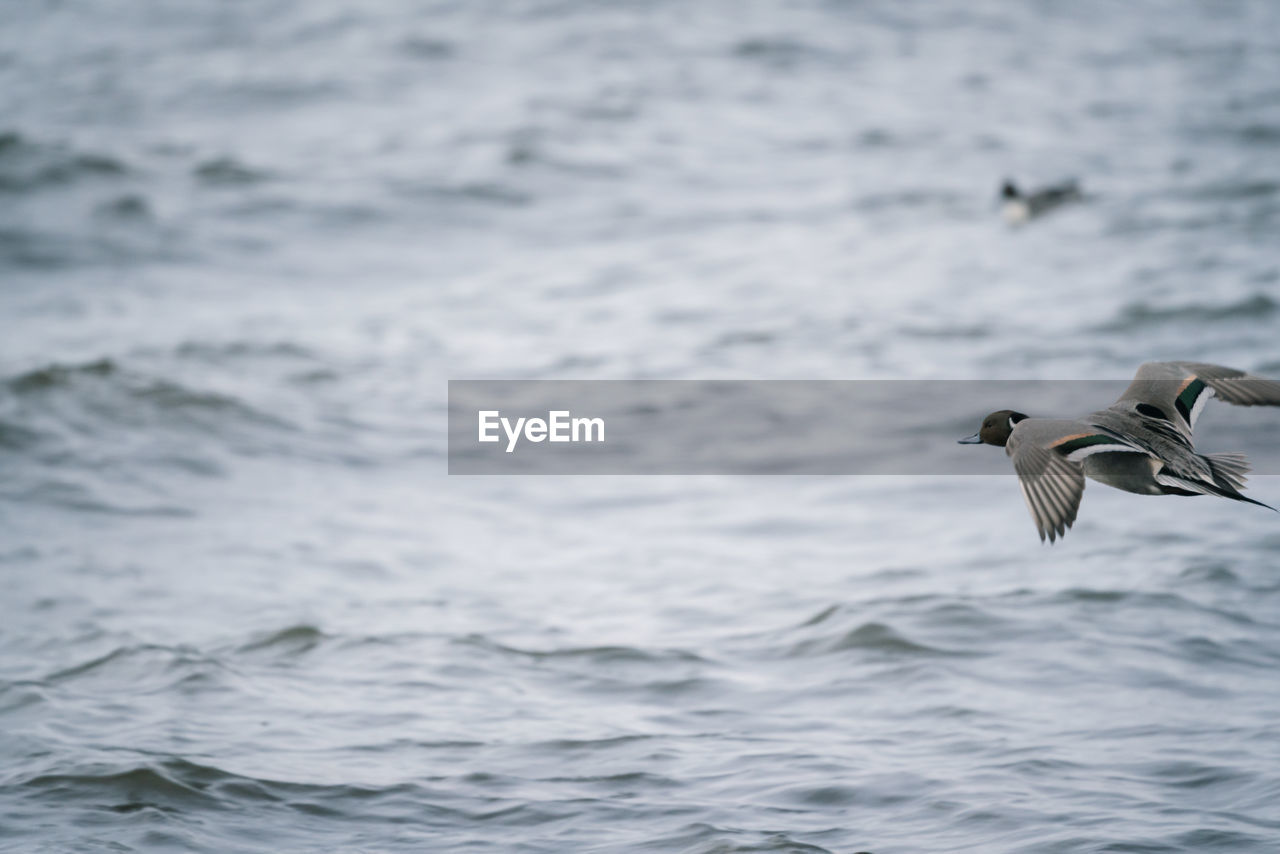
[[1116, 362, 1280, 444]]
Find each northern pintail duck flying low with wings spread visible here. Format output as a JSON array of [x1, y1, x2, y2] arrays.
[[960, 362, 1280, 543]]
